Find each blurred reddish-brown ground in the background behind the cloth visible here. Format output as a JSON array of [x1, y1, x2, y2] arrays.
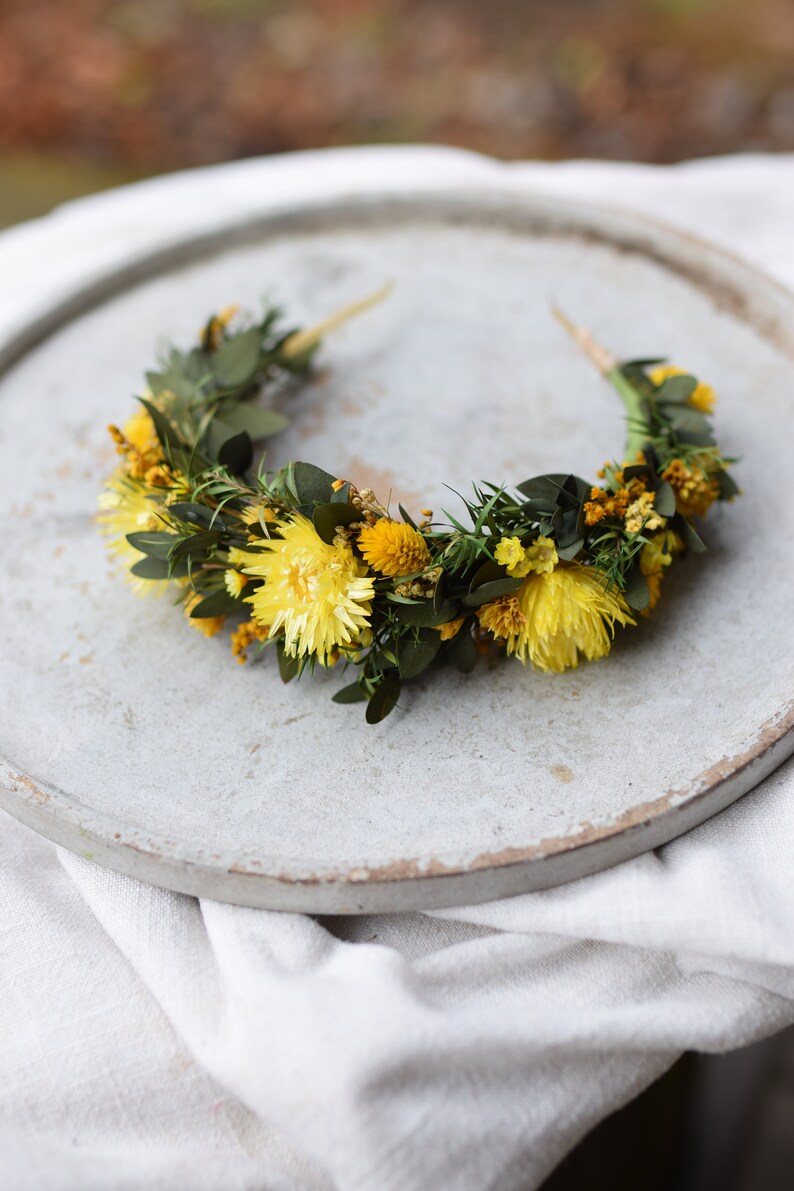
[[0, 0, 794, 220]]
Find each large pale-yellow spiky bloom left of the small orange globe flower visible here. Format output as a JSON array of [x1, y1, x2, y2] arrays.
[[244, 513, 375, 665]]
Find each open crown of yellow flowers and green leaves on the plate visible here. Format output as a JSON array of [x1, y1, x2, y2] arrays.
[[99, 293, 738, 723]]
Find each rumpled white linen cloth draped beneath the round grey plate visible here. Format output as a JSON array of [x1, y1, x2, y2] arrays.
[[0, 149, 794, 1191]]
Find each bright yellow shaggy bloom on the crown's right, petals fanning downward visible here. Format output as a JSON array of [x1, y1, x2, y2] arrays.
[[480, 562, 636, 672]]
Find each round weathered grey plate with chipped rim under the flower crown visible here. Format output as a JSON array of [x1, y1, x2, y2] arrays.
[[0, 172, 794, 912]]
